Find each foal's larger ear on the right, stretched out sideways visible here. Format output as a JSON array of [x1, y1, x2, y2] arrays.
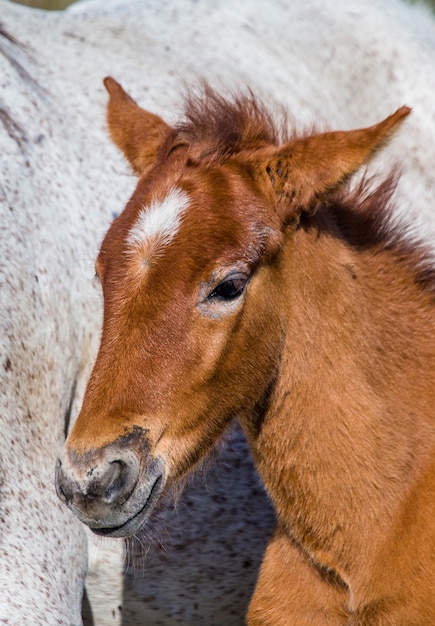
[[251, 106, 411, 223]]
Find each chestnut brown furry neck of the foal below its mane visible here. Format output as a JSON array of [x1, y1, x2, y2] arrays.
[[247, 196, 435, 578]]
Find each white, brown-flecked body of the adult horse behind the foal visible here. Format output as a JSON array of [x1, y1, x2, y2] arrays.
[[0, 0, 435, 626]]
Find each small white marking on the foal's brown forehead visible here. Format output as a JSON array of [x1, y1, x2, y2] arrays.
[[127, 188, 189, 264]]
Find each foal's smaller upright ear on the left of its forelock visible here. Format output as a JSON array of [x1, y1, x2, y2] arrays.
[[104, 76, 171, 175]]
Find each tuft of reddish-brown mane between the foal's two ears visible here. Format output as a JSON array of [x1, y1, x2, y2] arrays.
[[169, 84, 289, 163]]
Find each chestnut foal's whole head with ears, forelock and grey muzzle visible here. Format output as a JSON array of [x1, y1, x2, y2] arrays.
[[56, 78, 409, 536]]
